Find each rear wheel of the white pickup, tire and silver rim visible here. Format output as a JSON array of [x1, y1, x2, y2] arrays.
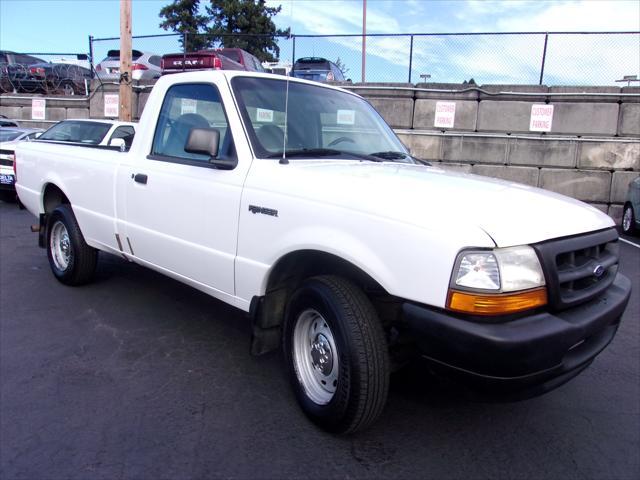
[[47, 205, 98, 286]]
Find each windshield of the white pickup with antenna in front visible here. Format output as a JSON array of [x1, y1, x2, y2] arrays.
[[231, 77, 413, 163]]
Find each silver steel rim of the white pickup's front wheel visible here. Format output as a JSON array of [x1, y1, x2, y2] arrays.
[[293, 309, 339, 405]]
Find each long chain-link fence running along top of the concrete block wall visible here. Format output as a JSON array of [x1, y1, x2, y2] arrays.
[[0, 32, 640, 95]]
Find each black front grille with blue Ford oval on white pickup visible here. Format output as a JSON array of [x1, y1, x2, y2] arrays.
[[533, 228, 618, 310]]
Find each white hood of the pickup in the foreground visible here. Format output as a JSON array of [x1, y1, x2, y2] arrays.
[[273, 159, 614, 247]]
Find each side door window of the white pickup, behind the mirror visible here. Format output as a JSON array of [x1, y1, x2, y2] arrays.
[[151, 84, 235, 165]]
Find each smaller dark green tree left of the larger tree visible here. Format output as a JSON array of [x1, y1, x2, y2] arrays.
[[159, 0, 213, 52]]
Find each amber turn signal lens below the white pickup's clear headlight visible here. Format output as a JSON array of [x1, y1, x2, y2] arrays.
[[447, 287, 547, 315]]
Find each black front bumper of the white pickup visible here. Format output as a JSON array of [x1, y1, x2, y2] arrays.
[[403, 274, 631, 398]]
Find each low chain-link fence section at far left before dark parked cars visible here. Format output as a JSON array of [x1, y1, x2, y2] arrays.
[[0, 52, 92, 95]]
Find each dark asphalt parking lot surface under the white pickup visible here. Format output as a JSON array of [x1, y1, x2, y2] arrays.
[[0, 202, 640, 480]]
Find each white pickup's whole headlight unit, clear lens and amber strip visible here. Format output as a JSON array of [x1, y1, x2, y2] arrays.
[[447, 245, 547, 315]]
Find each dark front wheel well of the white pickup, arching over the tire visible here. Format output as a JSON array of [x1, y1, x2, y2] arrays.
[[251, 250, 400, 354]]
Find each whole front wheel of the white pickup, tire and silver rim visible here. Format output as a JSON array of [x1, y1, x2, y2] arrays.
[[283, 276, 389, 433]]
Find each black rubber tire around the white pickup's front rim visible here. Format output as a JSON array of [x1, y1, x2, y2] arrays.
[[283, 276, 390, 433]]
